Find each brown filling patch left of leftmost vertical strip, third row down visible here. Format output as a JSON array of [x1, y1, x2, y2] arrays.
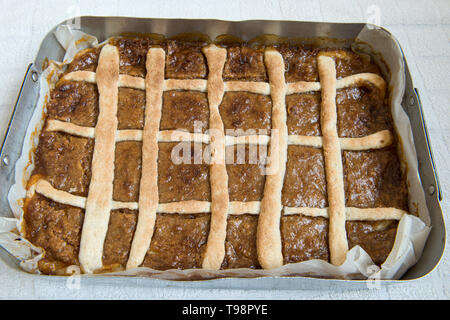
[[33, 131, 94, 196]]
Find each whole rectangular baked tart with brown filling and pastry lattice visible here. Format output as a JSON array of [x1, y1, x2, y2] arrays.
[[23, 37, 409, 274]]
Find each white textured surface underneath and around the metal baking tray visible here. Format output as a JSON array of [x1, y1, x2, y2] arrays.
[[0, 0, 450, 300]]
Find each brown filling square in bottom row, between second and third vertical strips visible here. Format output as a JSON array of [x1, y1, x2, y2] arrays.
[[142, 214, 210, 270]]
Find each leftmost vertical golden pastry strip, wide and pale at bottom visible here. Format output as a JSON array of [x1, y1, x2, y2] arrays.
[[79, 45, 119, 273]]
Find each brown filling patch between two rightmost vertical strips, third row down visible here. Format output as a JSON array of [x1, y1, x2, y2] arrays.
[[282, 146, 328, 208]]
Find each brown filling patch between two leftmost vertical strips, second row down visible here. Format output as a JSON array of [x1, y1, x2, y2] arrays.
[[117, 88, 145, 130]]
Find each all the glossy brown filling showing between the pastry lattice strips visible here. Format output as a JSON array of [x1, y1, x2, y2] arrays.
[[25, 38, 408, 274]]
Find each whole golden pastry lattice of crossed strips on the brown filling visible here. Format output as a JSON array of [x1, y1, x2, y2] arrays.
[[27, 45, 408, 272]]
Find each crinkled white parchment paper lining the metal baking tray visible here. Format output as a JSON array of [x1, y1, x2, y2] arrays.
[[0, 26, 431, 280]]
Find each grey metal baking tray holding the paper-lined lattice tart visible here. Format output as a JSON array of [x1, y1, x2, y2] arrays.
[[0, 16, 446, 290]]
